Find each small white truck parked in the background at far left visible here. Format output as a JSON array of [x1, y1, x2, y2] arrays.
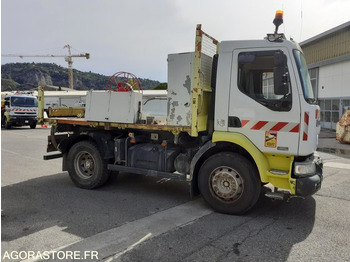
[[1, 93, 38, 129]]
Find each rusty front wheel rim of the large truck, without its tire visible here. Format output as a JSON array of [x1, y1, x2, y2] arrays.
[[210, 167, 244, 202]]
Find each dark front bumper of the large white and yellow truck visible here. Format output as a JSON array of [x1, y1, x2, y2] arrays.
[[294, 154, 323, 197]]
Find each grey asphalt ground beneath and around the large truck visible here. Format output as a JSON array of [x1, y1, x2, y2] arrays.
[[1, 127, 350, 262]]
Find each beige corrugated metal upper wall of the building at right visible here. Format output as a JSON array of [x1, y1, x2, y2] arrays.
[[302, 27, 350, 65]]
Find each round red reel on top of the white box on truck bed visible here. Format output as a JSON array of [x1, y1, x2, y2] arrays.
[[106, 72, 142, 92]]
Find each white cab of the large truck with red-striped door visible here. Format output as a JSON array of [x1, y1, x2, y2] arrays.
[[214, 39, 320, 156]]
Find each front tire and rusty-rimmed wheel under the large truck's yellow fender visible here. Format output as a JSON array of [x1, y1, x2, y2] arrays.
[[198, 152, 261, 215]]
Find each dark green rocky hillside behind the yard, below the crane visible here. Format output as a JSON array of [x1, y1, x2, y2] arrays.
[[1, 63, 160, 91]]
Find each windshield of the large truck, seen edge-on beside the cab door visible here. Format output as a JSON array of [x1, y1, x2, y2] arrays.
[[294, 50, 316, 104]]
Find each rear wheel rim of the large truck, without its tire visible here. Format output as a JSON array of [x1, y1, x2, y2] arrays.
[[74, 151, 95, 179]]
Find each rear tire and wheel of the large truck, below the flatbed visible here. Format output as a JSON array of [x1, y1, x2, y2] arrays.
[[67, 141, 111, 189]]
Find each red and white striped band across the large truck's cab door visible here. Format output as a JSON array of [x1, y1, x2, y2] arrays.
[[241, 120, 300, 133]]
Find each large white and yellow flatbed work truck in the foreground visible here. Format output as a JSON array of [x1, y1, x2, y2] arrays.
[[39, 11, 322, 214]]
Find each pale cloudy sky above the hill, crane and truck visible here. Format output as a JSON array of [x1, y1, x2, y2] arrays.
[[1, 0, 350, 82]]
